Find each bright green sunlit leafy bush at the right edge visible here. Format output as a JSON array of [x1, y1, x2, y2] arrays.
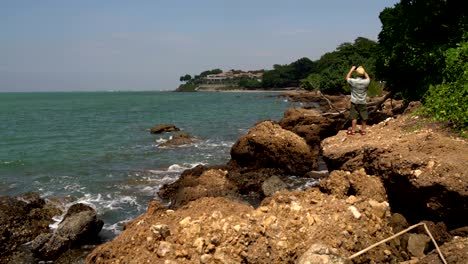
[[424, 34, 468, 130]]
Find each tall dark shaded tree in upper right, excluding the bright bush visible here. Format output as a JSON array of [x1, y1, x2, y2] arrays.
[[376, 0, 468, 100]]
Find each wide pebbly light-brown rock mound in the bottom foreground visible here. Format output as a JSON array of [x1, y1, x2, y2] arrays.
[[87, 176, 404, 263]]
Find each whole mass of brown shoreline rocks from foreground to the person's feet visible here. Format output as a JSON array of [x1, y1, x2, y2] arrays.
[[2, 92, 468, 263]]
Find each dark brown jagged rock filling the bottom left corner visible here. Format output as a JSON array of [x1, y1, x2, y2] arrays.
[[0, 193, 61, 263]]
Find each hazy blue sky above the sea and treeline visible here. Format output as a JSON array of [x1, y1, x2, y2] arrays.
[[0, 0, 399, 92]]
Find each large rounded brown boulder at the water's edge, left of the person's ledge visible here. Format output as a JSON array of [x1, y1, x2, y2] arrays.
[[231, 121, 318, 176]]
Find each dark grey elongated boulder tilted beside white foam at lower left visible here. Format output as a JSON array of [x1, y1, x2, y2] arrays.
[[32, 203, 104, 260]]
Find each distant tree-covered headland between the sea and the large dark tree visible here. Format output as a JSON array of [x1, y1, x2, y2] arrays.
[[180, 37, 378, 93]]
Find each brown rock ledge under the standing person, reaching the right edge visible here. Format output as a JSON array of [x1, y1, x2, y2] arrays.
[[322, 115, 468, 229]]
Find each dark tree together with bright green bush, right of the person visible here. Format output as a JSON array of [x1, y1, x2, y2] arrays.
[[376, 0, 468, 131]]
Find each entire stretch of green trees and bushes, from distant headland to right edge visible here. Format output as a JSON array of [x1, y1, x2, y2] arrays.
[[181, 0, 468, 130]]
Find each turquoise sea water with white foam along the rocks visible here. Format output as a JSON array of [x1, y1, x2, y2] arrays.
[[0, 92, 291, 237]]
